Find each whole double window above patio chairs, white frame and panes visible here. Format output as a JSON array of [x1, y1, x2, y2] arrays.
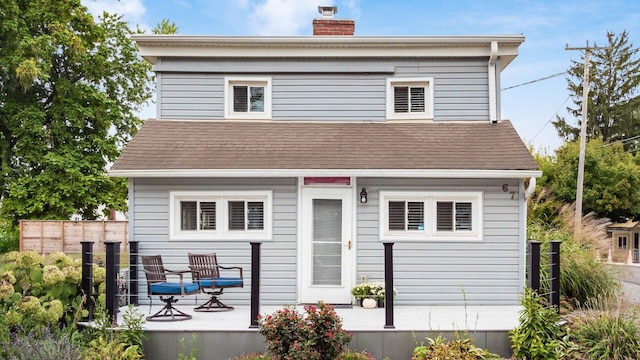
[[169, 191, 271, 240]]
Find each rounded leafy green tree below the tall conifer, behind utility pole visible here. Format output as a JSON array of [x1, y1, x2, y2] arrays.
[[542, 139, 640, 220]]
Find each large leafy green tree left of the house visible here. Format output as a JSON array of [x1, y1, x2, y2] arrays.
[[0, 0, 153, 225]]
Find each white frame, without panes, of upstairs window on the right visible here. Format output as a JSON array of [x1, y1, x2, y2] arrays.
[[386, 77, 433, 120]]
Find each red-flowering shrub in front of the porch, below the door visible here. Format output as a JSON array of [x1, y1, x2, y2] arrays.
[[259, 302, 351, 360]]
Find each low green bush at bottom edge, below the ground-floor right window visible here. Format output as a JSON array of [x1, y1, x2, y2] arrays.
[[411, 334, 501, 360]]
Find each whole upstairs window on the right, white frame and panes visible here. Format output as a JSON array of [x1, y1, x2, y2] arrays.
[[387, 78, 433, 120]]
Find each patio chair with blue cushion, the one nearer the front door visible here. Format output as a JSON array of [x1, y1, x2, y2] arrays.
[[189, 253, 244, 312]]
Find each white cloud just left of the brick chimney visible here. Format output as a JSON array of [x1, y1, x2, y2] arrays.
[[249, 0, 333, 35]]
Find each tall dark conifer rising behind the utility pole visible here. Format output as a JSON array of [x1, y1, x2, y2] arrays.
[[553, 31, 640, 149]]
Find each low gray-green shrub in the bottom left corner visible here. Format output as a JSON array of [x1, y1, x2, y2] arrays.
[[2, 327, 82, 360]]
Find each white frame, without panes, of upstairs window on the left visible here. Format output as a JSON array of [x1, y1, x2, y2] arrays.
[[224, 76, 272, 119]]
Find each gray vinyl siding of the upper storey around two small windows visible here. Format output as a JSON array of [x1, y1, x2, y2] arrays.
[[156, 58, 489, 121]]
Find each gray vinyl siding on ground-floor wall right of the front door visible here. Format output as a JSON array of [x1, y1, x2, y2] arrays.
[[356, 178, 524, 306]]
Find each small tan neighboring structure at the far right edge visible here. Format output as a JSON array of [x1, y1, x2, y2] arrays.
[[607, 221, 640, 263]]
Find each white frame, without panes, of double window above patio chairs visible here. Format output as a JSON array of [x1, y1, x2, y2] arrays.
[[169, 191, 273, 240]]
